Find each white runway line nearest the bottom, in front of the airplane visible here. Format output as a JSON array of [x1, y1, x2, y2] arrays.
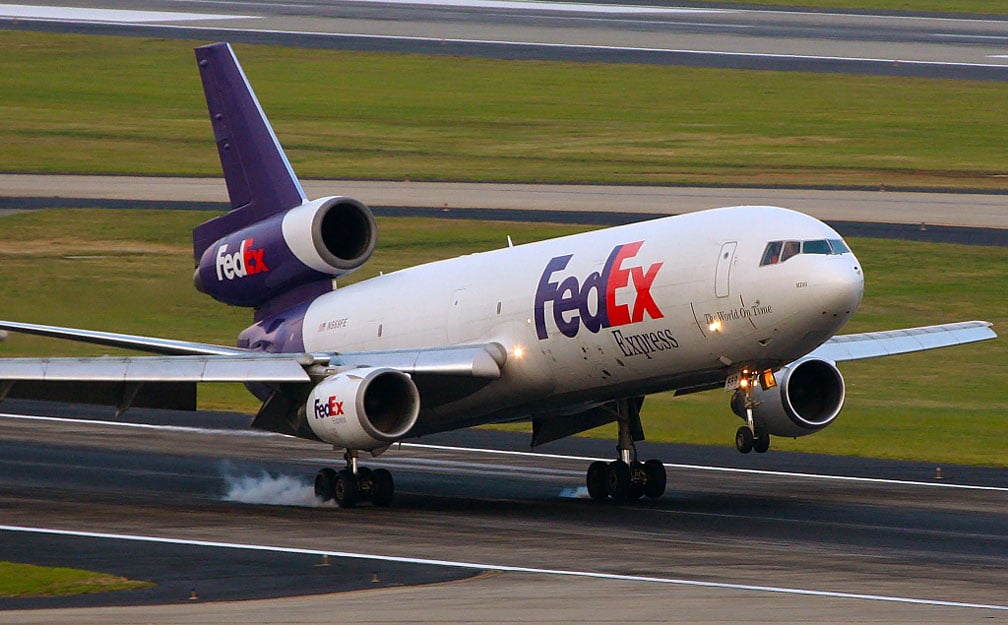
[[0, 525, 1008, 612]]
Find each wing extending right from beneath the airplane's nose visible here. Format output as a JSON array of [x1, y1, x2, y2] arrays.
[[809, 322, 997, 362]]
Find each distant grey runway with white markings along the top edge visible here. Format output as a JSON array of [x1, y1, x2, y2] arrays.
[[0, 0, 1008, 81]]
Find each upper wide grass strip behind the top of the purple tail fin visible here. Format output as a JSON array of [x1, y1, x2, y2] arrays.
[[0, 31, 1008, 190]]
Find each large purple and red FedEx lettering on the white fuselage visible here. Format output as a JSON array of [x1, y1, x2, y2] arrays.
[[535, 241, 664, 340]]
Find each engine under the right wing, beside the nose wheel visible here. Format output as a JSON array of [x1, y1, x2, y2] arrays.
[[732, 358, 846, 436]]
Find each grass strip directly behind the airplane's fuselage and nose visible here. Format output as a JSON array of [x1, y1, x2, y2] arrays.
[[0, 207, 1008, 466]]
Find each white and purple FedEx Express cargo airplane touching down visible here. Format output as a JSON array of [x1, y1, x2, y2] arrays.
[[0, 42, 996, 507]]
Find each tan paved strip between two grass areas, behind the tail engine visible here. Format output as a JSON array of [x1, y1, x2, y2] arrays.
[[0, 174, 1008, 246]]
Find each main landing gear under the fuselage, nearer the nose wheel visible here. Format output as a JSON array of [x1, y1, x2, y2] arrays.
[[587, 397, 667, 501]]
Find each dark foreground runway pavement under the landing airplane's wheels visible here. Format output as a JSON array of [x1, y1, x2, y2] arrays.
[[0, 402, 1008, 623]]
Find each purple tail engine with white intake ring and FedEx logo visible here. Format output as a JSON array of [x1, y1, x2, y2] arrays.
[[193, 198, 378, 306]]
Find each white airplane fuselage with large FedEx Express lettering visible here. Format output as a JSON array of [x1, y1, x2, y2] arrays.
[[303, 207, 864, 430]]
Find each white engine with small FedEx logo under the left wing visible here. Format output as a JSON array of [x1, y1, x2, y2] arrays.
[[305, 368, 420, 452]]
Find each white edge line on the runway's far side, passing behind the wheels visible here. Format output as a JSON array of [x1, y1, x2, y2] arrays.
[[0, 413, 1008, 493]]
